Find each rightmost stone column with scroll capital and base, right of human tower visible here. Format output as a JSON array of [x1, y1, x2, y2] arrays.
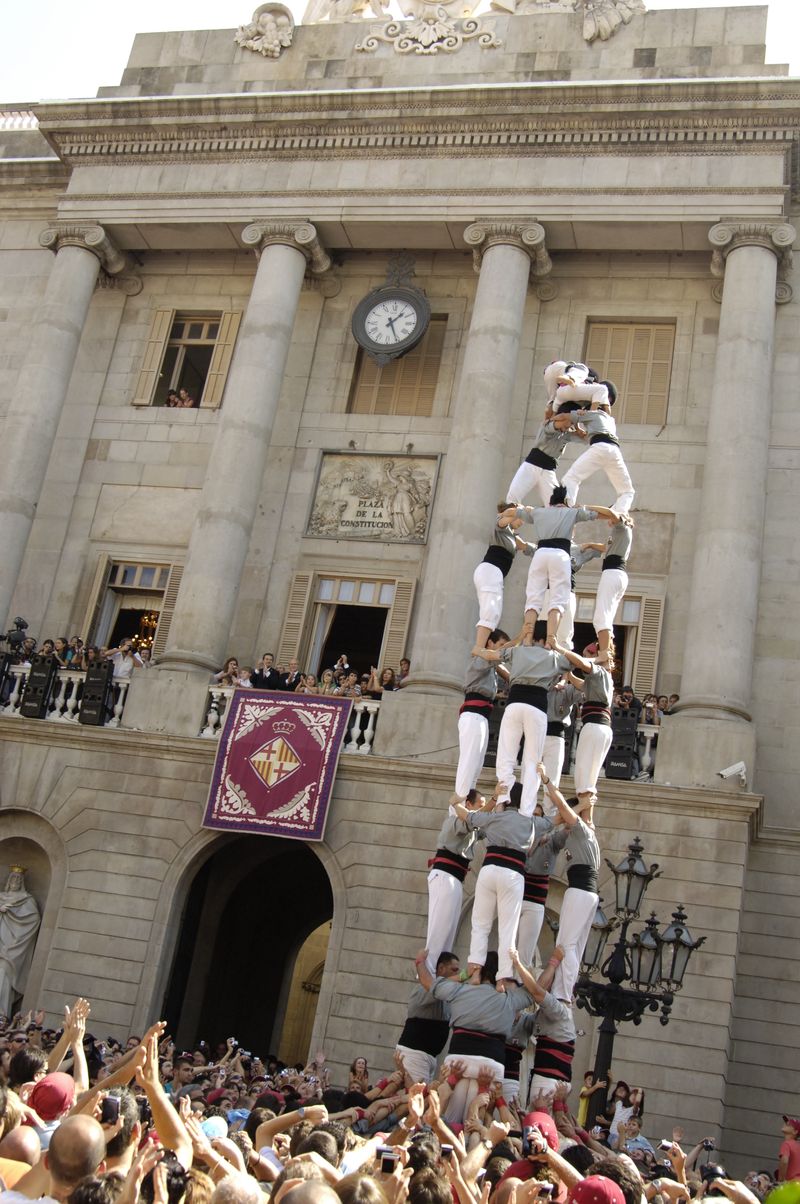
[[655, 222, 795, 790]]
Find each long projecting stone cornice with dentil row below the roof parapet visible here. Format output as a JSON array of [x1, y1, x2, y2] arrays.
[[31, 79, 800, 165]]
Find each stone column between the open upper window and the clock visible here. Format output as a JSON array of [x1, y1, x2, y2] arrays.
[[161, 222, 330, 673]]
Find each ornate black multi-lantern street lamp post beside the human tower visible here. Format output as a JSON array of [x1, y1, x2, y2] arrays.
[[575, 837, 706, 1126]]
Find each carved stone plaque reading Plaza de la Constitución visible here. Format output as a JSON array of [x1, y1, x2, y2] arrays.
[[306, 452, 439, 543]]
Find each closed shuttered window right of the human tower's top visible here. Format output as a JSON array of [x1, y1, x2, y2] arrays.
[[584, 321, 675, 426]]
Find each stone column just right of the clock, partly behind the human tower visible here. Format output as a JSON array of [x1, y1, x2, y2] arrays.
[[375, 220, 551, 755]]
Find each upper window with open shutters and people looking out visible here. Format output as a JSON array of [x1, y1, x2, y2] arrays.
[[133, 309, 242, 408]]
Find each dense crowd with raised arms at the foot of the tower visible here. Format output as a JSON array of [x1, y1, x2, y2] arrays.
[[0, 992, 800, 1204]]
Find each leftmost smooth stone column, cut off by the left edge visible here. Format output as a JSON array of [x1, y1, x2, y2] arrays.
[[0, 224, 128, 631]]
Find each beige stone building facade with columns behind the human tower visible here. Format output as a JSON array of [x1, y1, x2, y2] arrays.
[[0, 0, 800, 1169]]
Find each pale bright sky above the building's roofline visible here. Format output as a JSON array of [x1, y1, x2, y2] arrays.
[[0, 0, 800, 104]]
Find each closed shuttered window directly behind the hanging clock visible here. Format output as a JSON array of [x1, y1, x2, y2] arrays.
[[347, 315, 447, 418]]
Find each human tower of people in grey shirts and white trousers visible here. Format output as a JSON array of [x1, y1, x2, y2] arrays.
[[398, 360, 634, 1121]]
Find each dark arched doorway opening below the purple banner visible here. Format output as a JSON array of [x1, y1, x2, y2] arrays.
[[164, 836, 334, 1054]]
